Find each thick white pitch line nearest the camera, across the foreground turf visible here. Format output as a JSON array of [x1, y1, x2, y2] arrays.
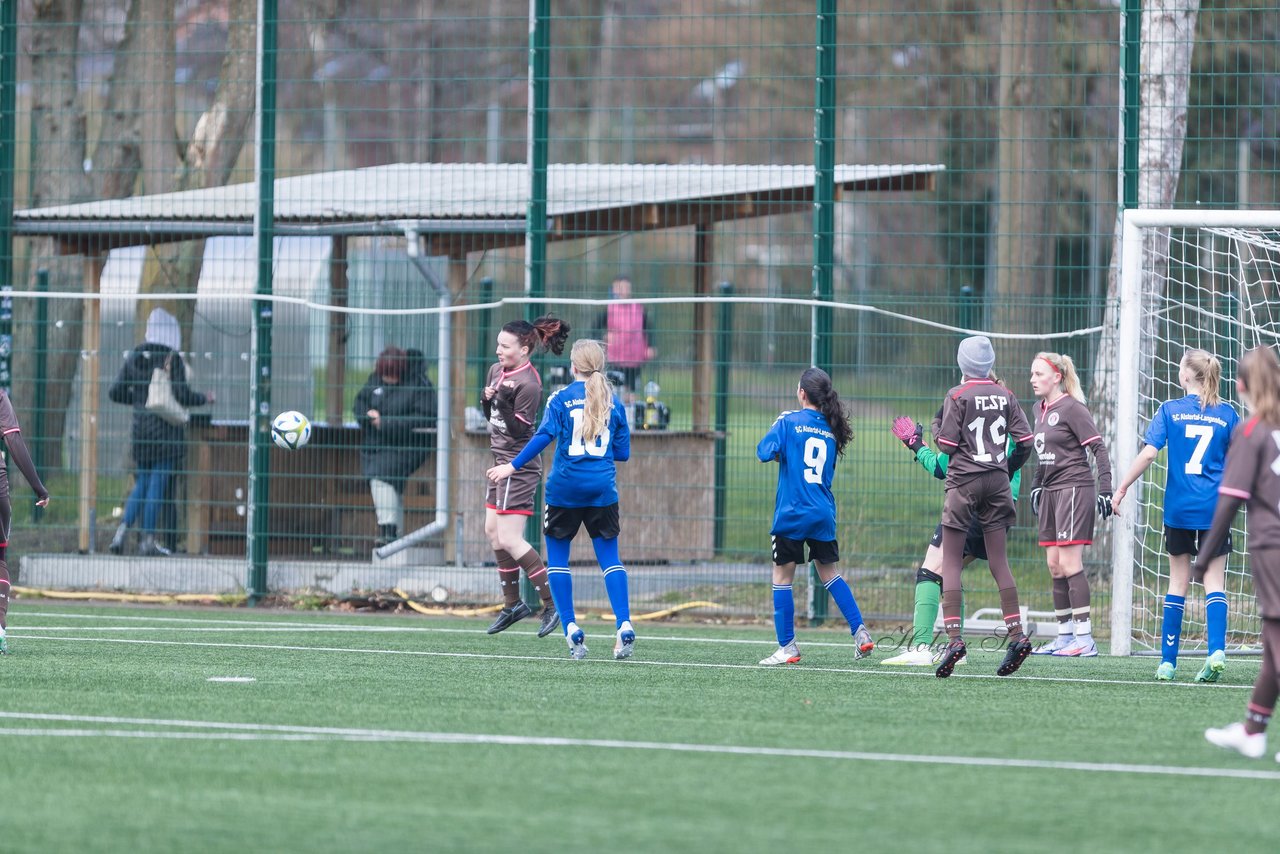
[[0, 712, 1280, 781]]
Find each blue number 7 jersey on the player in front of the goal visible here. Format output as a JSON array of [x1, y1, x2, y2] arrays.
[[1143, 394, 1240, 531]]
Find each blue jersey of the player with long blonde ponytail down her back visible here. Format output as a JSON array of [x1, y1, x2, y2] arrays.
[[512, 380, 631, 507]]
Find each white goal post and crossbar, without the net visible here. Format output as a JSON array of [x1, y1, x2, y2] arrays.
[[1111, 209, 1280, 656]]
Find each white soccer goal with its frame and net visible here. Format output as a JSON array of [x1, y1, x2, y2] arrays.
[[1111, 210, 1280, 656]]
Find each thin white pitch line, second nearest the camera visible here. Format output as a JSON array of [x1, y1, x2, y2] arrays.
[[9, 629, 1253, 691]]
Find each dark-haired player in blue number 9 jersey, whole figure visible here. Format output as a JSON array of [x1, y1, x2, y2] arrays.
[[755, 367, 876, 666]]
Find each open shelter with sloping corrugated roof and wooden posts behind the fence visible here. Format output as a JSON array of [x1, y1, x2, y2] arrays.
[[14, 164, 943, 573]]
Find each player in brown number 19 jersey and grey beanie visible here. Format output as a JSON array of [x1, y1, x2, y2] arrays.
[[934, 335, 1032, 679]]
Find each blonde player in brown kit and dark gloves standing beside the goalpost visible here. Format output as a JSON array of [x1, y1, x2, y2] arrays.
[[1032, 353, 1111, 658]]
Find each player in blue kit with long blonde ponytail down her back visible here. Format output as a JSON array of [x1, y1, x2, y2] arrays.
[[488, 339, 636, 659]]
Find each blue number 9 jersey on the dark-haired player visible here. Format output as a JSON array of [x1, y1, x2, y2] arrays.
[[755, 410, 836, 542]]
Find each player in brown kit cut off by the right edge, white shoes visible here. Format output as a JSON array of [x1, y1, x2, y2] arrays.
[[1192, 347, 1280, 762]]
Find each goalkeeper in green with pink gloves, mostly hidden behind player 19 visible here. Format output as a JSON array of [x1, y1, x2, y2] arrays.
[[881, 396, 1021, 667]]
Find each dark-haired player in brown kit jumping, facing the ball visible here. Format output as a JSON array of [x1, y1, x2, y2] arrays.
[[481, 315, 570, 638]]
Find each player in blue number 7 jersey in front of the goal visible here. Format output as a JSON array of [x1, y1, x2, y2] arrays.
[[1112, 350, 1240, 682]]
